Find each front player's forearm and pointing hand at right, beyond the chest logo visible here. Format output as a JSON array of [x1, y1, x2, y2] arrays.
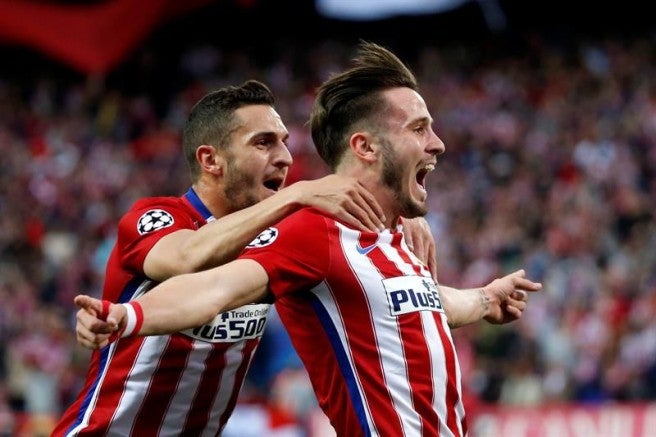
[[439, 269, 542, 328]]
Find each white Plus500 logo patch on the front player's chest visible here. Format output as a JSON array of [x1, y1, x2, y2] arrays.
[[383, 276, 444, 316]]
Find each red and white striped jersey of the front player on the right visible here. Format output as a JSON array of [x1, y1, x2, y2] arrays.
[[241, 209, 467, 437]]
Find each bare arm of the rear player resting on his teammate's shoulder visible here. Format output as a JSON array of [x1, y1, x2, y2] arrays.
[[144, 175, 384, 281]]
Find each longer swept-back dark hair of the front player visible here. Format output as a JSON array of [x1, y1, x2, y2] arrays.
[[310, 41, 418, 170]]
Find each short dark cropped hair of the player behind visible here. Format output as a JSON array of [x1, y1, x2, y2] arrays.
[[182, 80, 275, 181]]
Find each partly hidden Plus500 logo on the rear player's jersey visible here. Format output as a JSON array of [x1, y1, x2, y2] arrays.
[[182, 304, 269, 343]]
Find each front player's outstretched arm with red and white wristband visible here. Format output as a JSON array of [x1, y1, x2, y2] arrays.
[[75, 259, 269, 348]]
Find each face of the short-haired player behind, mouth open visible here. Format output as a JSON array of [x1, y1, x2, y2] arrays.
[[223, 105, 292, 211]]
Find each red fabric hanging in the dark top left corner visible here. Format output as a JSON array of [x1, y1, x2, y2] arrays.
[[0, 0, 212, 73]]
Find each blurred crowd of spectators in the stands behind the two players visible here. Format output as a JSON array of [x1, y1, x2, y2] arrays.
[[0, 2, 656, 436]]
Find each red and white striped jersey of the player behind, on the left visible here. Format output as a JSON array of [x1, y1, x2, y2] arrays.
[[52, 190, 269, 437]]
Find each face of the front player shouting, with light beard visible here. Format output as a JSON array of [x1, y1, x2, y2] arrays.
[[378, 88, 445, 218]]
